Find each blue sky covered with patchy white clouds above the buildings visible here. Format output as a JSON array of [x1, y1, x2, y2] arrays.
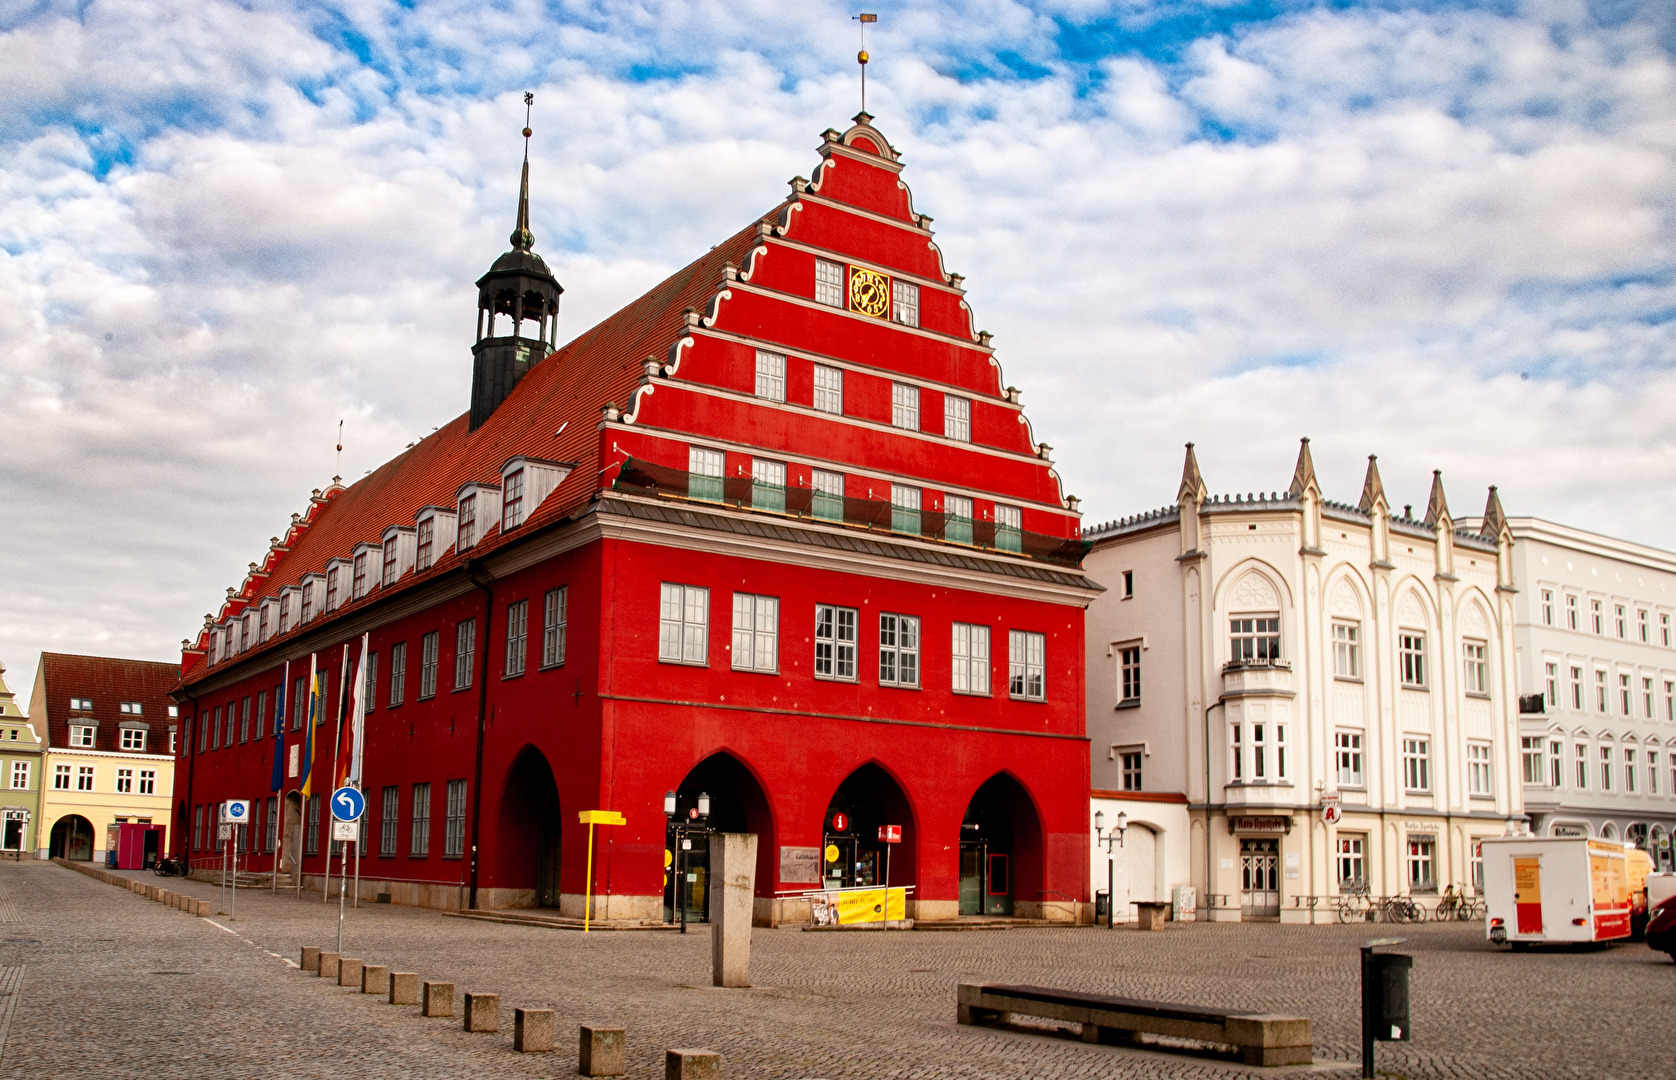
[[0, 0, 1676, 693]]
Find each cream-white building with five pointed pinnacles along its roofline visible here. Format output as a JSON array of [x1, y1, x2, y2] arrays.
[[1084, 439, 1523, 921]]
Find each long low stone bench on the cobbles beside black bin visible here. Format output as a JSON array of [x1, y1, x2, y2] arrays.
[[957, 983, 1314, 1065]]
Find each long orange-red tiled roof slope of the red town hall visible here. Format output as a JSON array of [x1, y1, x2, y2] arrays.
[[183, 206, 781, 683]]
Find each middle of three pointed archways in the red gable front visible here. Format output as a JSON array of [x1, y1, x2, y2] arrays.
[[821, 761, 918, 889]]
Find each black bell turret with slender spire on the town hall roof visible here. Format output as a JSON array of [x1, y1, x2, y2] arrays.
[[471, 94, 565, 431]]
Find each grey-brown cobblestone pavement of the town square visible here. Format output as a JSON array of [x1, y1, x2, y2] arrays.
[[0, 862, 1676, 1080]]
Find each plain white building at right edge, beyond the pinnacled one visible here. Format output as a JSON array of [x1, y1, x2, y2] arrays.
[[1508, 518, 1676, 869]]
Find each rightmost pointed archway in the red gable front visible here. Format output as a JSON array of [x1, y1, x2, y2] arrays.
[[960, 773, 1044, 916]]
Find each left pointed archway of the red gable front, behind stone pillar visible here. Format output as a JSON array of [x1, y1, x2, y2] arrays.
[[664, 753, 778, 921]]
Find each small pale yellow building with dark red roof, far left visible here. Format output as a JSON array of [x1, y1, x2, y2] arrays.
[[28, 652, 179, 869]]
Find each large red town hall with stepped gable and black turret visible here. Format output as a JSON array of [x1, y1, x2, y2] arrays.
[[174, 114, 1098, 922]]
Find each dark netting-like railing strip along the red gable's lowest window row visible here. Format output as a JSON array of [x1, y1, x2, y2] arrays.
[[612, 458, 1091, 567]]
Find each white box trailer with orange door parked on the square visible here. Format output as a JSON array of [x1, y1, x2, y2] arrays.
[[1482, 837, 1629, 946]]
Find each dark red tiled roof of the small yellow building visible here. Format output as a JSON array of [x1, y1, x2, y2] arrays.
[[28, 652, 181, 753]]
